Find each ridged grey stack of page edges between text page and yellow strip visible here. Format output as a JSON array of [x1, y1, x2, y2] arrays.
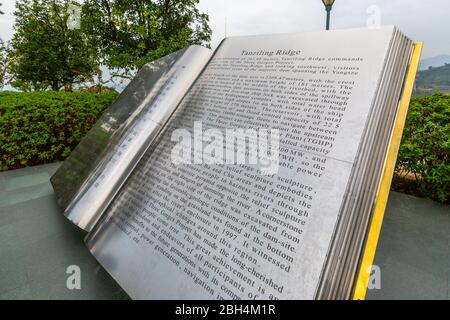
[[319, 29, 413, 299]]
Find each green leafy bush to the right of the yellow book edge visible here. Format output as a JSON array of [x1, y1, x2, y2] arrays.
[[393, 93, 450, 203]]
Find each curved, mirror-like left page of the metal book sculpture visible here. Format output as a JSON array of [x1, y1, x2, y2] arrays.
[[52, 46, 212, 231]]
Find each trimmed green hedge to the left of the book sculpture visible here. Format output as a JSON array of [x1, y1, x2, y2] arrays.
[[0, 91, 117, 171]]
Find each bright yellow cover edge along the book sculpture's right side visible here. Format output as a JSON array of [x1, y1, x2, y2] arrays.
[[353, 42, 423, 300]]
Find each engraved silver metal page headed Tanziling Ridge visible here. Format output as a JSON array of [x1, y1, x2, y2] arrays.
[[86, 27, 394, 299]]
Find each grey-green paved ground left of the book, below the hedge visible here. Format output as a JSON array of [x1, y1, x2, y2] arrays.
[[0, 164, 128, 299]]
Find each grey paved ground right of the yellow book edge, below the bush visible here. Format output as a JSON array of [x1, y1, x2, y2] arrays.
[[367, 188, 450, 299]]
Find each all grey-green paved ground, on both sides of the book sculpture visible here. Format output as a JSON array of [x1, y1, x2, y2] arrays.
[[0, 164, 450, 299]]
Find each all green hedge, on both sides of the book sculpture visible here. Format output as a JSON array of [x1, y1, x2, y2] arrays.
[[0, 92, 450, 203]]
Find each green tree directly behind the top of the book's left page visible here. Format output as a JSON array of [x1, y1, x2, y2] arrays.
[[83, 0, 211, 77]]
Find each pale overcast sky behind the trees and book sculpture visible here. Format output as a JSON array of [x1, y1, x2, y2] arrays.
[[0, 0, 450, 58]]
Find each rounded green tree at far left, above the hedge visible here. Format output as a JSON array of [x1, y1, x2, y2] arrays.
[[9, 0, 98, 91]]
